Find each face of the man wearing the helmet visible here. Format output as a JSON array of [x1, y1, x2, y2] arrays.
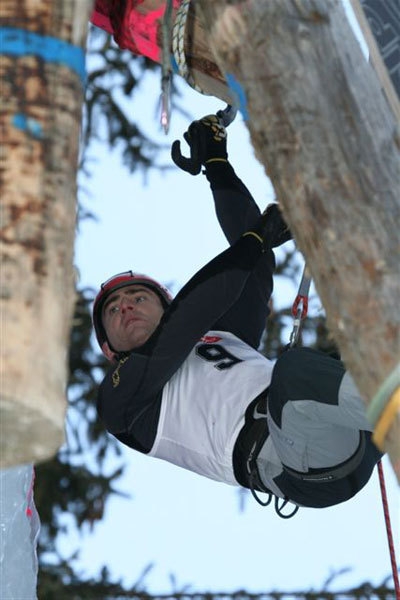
[[102, 284, 164, 352]]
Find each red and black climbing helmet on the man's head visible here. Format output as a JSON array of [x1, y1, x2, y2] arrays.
[[93, 271, 173, 348]]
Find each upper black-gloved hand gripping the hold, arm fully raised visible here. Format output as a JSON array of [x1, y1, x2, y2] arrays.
[[171, 115, 228, 175]]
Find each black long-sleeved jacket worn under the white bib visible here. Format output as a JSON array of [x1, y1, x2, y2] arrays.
[[97, 162, 275, 453]]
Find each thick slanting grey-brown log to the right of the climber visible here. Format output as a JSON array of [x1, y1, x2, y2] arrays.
[[198, 0, 400, 481]]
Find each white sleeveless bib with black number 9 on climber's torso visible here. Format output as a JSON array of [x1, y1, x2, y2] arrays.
[[149, 331, 273, 485]]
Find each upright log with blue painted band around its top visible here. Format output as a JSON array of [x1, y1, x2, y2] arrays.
[[0, 0, 90, 467]]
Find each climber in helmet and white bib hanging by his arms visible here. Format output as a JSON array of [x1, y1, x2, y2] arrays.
[[93, 115, 381, 508]]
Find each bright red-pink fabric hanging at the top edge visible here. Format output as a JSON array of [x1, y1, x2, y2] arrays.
[[90, 0, 181, 63]]
